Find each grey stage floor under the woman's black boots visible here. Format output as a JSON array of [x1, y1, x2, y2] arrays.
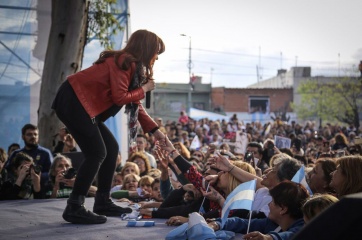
[[0, 198, 180, 240]]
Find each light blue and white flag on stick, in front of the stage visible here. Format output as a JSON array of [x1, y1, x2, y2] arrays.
[[220, 179, 256, 229]]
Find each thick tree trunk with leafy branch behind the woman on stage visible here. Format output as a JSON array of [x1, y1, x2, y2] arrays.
[[38, 0, 122, 149]]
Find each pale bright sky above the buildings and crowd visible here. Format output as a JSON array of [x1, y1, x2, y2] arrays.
[[125, 0, 362, 88]]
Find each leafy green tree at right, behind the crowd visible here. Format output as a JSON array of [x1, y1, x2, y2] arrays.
[[292, 71, 362, 128]]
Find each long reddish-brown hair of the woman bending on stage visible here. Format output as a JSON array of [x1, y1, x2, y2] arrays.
[[94, 29, 165, 81]]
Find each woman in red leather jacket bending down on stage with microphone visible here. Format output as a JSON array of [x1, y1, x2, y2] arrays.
[[52, 30, 165, 224]]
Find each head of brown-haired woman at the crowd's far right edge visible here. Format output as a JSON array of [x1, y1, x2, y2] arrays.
[[330, 155, 362, 198]]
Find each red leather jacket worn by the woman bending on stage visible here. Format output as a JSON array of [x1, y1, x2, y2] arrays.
[[68, 56, 158, 132]]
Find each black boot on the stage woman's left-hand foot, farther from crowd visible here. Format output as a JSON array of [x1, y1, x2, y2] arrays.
[[63, 194, 107, 224]]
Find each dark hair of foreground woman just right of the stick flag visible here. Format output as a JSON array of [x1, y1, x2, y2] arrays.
[[269, 180, 309, 219]]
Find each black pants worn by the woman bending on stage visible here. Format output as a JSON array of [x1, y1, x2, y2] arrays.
[[52, 81, 119, 196]]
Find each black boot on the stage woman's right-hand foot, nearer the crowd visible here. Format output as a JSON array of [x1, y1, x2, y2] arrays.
[[93, 192, 132, 217]]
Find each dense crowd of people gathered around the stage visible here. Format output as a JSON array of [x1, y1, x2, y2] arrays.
[[0, 112, 362, 239]]
